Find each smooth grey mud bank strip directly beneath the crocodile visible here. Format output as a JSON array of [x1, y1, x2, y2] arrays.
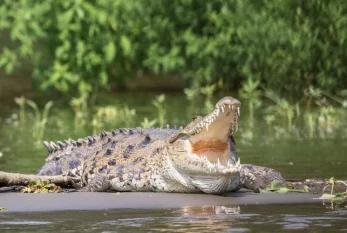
[[0, 192, 321, 212]]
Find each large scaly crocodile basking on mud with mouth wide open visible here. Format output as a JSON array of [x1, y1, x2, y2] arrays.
[[37, 97, 285, 194]]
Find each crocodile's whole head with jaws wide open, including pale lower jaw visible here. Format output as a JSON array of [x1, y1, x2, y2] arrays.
[[169, 97, 241, 193]]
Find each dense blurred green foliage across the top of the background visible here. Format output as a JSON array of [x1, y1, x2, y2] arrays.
[[0, 0, 347, 97]]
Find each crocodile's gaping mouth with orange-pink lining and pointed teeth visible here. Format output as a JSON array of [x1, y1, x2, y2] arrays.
[[189, 98, 240, 169]]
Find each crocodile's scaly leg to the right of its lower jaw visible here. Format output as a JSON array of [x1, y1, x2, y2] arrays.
[[240, 164, 286, 192]]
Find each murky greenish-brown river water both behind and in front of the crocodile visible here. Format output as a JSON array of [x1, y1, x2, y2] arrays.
[[0, 93, 347, 232]]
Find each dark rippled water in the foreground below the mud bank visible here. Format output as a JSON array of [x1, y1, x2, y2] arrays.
[[0, 204, 347, 233]]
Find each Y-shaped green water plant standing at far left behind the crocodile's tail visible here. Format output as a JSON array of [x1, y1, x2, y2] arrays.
[[26, 100, 53, 142]]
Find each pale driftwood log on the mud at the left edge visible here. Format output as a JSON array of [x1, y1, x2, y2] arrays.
[[0, 171, 79, 187]]
